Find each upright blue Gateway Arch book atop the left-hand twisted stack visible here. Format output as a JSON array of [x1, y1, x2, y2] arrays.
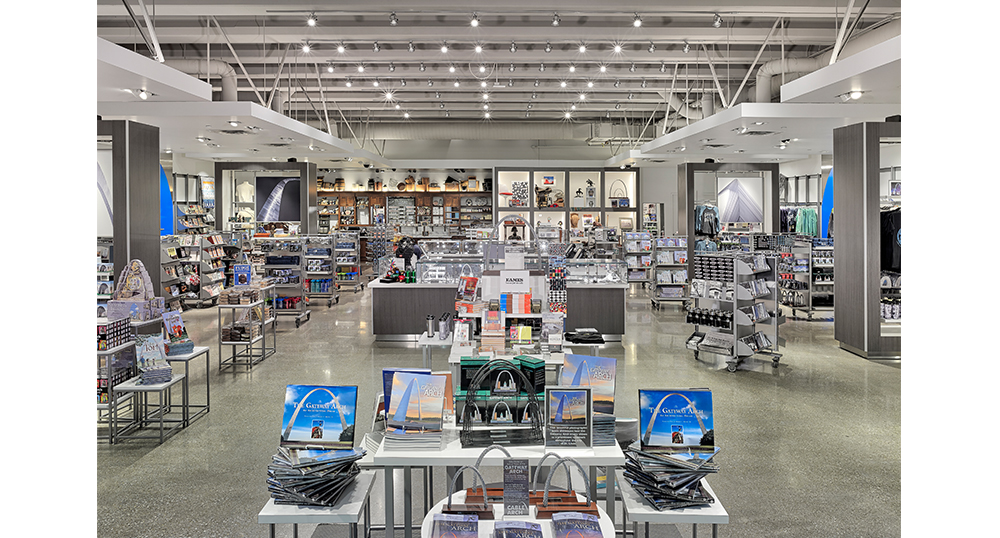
[[280, 385, 358, 449]]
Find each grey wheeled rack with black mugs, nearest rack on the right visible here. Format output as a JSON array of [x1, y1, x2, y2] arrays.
[[687, 252, 785, 372]]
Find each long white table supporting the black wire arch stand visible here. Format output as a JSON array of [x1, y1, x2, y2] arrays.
[[372, 430, 625, 538]]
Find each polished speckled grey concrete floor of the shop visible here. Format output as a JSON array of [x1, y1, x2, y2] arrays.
[[97, 289, 901, 538]]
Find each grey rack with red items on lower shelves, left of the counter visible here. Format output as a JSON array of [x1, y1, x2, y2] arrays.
[[261, 237, 309, 328]]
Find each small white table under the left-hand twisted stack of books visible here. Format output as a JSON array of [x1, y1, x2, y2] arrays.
[[257, 471, 375, 538]]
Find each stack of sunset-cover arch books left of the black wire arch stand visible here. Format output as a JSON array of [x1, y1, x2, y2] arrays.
[[382, 372, 447, 450]]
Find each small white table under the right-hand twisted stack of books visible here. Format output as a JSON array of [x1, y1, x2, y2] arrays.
[[605, 469, 729, 538]]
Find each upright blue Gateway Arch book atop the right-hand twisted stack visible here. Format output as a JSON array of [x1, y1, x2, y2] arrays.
[[639, 389, 715, 452]]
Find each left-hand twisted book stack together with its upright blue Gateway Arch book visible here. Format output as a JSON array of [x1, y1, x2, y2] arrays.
[[267, 385, 365, 506]]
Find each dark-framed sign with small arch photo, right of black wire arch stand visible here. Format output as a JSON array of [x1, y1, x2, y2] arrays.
[[545, 387, 593, 447]]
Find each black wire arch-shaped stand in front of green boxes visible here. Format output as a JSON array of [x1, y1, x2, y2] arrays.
[[459, 359, 545, 448]]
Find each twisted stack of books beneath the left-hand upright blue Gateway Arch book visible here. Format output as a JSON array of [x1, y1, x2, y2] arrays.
[[267, 448, 365, 506]]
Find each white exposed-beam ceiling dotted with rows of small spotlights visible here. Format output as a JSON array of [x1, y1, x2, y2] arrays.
[[97, 0, 901, 168]]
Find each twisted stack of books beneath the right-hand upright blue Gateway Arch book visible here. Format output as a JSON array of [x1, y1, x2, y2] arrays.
[[624, 443, 719, 510]]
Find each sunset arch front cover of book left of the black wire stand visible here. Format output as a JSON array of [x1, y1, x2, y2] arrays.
[[386, 372, 447, 430]]
